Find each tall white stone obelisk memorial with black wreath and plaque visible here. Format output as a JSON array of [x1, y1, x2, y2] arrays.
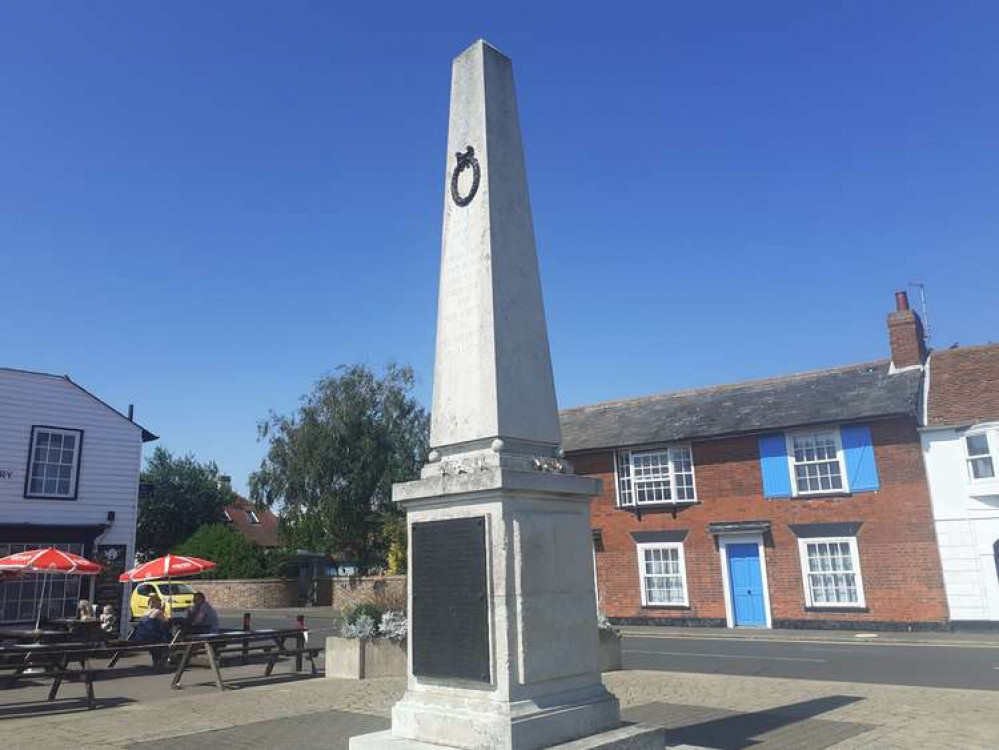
[[350, 40, 664, 750]]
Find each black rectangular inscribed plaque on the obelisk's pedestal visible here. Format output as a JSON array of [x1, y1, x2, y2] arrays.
[[410, 516, 489, 682]]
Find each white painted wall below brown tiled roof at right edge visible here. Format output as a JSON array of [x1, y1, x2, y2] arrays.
[[920, 425, 999, 621]]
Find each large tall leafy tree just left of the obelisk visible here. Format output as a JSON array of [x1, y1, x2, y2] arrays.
[[250, 365, 429, 568]]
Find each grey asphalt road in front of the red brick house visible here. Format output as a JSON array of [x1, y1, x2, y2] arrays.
[[622, 635, 999, 690]]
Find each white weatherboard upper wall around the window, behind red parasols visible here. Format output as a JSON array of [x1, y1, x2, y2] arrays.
[[0, 369, 148, 624]]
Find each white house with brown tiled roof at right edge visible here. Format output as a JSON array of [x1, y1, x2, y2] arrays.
[[920, 345, 999, 628]]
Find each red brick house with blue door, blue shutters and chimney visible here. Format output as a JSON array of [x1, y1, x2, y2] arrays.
[[562, 294, 948, 629]]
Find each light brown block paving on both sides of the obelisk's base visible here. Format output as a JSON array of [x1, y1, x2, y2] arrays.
[[0, 664, 999, 750]]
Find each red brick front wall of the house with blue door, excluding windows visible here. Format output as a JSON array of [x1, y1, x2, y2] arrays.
[[569, 419, 948, 629]]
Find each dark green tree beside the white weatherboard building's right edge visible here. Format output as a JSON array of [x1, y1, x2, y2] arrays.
[[135, 447, 235, 557]]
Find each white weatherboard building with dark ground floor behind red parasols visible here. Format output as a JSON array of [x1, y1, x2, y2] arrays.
[[0, 368, 156, 624]]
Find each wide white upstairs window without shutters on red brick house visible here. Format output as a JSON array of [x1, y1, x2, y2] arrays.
[[617, 443, 697, 508]]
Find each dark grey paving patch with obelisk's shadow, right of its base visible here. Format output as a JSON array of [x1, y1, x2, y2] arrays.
[[624, 695, 874, 750]]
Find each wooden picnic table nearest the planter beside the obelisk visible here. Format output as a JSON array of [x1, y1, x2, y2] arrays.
[[170, 628, 320, 690]]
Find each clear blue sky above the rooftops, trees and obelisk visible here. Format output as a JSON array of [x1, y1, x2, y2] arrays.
[[0, 0, 999, 496]]
